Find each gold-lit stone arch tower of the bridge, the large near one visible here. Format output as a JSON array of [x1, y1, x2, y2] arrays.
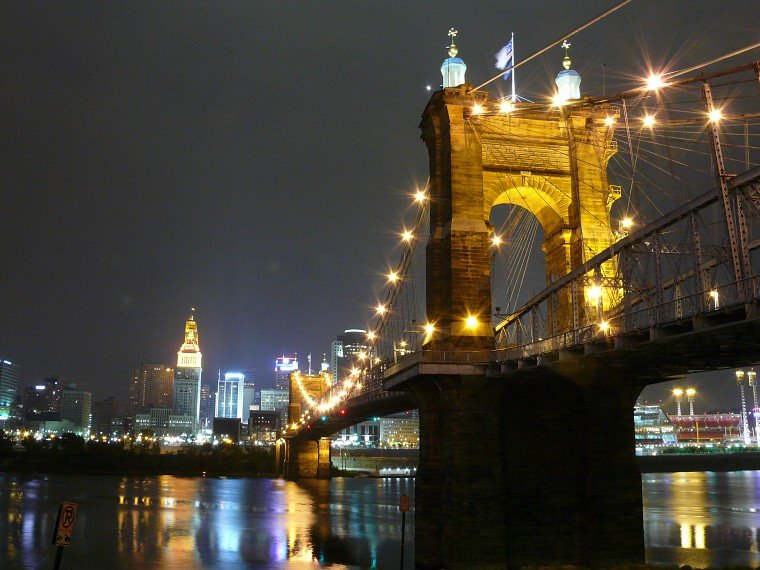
[[420, 84, 619, 344]]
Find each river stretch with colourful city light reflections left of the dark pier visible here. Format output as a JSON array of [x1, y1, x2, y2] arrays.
[[0, 475, 413, 569]]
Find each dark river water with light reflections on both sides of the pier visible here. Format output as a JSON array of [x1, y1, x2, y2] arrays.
[[0, 471, 760, 570]]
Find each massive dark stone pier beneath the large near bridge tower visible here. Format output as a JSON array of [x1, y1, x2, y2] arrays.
[[409, 370, 644, 569]]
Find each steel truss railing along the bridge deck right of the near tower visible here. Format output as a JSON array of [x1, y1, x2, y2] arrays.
[[496, 168, 760, 356]]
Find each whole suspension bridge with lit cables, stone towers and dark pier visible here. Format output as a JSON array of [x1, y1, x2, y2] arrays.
[[281, 54, 760, 568]]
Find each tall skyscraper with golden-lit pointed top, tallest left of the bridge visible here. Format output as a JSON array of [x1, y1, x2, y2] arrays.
[[173, 309, 202, 426]]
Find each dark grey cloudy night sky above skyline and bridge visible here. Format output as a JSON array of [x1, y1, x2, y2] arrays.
[[0, 0, 760, 409]]
